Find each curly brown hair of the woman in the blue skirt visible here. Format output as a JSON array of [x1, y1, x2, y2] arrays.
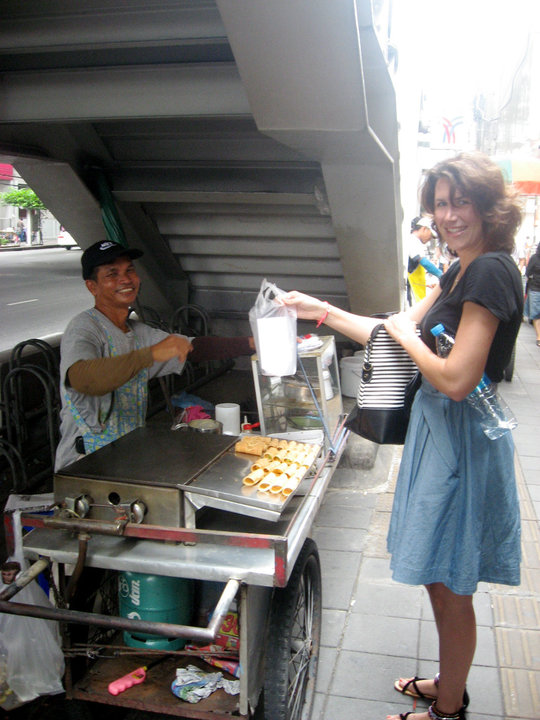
[[420, 152, 521, 253]]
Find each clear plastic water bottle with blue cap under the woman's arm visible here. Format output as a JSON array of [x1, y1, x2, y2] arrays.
[[431, 323, 517, 440]]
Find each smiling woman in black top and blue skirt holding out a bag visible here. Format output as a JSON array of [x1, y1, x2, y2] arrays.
[[284, 154, 523, 720]]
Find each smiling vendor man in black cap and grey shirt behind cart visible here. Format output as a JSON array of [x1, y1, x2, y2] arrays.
[[55, 240, 254, 470]]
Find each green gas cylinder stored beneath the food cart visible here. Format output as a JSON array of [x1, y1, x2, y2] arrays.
[[118, 572, 193, 650]]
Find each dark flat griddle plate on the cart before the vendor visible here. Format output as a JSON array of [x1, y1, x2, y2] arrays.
[[57, 426, 238, 487]]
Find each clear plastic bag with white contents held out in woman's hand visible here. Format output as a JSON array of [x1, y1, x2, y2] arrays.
[[249, 278, 298, 377]]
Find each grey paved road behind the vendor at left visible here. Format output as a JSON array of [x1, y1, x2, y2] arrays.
[[0, 248, 91, 352]]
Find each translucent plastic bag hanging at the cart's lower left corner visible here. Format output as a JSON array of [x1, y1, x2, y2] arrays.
[[0, 561, 64, 702]]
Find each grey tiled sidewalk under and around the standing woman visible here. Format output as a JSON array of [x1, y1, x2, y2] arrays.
[[312, 324, 540, 720]]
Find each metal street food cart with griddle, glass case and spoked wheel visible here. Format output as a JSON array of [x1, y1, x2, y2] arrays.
[[0, 338, 347, 720]]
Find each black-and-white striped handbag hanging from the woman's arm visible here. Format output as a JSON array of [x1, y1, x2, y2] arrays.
[[345, 324, 421, 445]]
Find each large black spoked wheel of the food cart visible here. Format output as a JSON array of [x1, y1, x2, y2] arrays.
[[264, 538, 322, 720]]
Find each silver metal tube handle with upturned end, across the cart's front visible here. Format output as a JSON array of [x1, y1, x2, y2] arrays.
[[0, 578, 240, 645]]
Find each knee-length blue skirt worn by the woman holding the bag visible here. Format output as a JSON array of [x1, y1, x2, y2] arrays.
[[388, 379, 521, 595]]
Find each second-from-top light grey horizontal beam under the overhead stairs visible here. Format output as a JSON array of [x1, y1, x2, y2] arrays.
[[0, 63, 250, 122]]
